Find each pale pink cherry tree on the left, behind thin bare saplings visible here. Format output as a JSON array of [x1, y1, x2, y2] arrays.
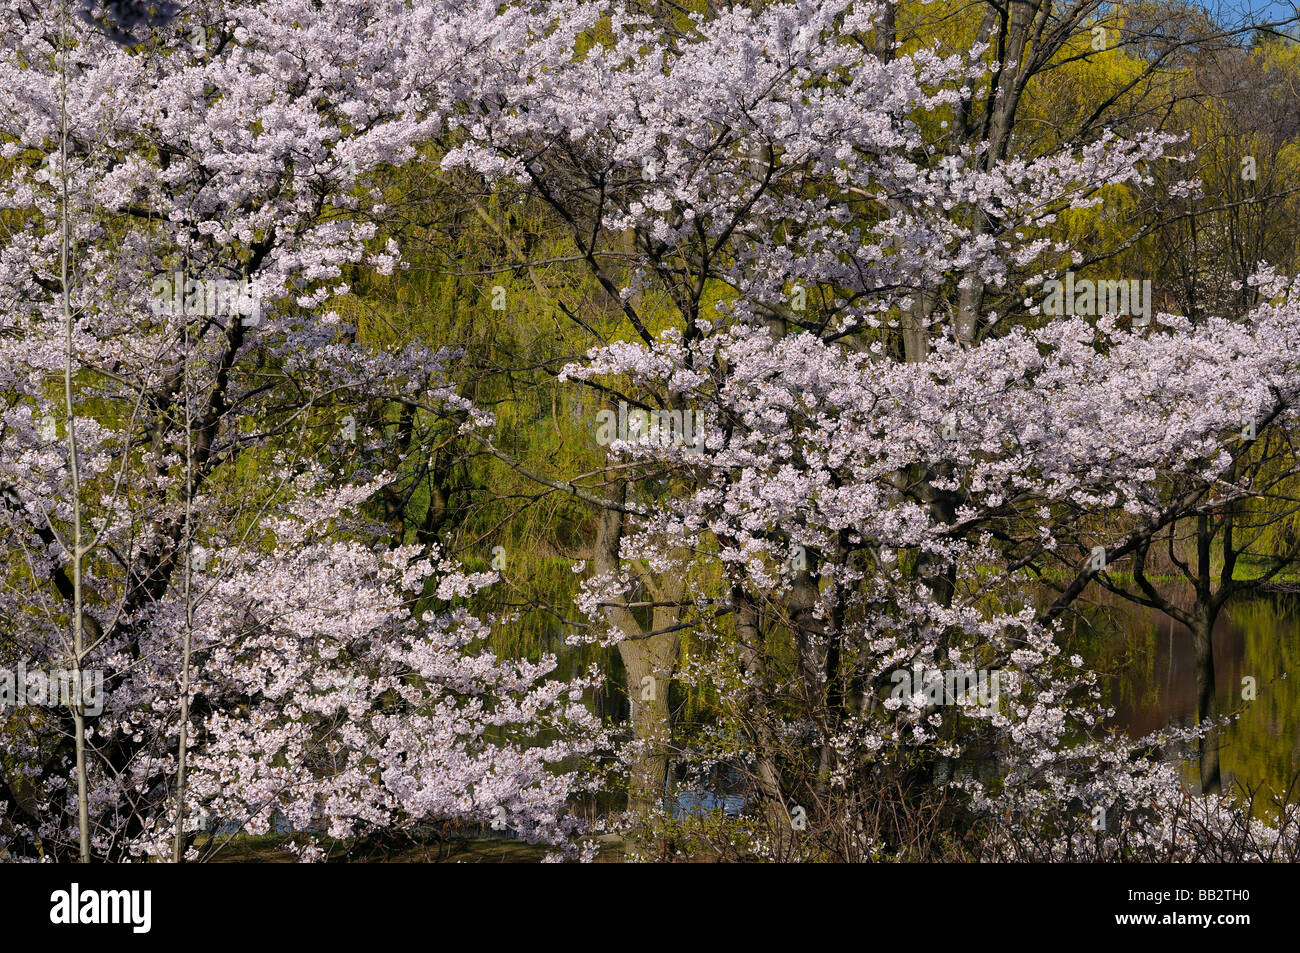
[[0, 1, 594, 859]]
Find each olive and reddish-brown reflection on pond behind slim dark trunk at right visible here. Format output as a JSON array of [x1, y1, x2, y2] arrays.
[[1074, 589, 1300, 793]]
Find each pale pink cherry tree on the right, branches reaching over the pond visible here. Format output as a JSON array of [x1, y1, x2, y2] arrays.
[[443, 3, 1296, 859]]
